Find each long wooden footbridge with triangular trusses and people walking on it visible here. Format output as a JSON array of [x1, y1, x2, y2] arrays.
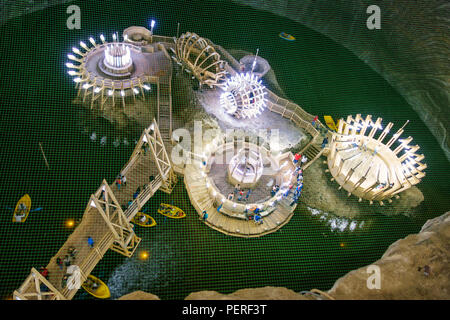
[[13, 120, 176, 300]]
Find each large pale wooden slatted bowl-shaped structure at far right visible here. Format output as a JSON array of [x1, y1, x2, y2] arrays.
[[327, 114, 427, 205]]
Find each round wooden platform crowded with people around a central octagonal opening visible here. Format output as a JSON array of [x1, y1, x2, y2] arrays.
[[184, 143, 297, 237]]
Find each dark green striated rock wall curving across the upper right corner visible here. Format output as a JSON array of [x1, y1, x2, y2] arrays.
[[232, 0, 450, 160]]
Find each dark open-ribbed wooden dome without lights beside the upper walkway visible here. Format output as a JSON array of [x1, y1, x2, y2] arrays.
[[176, 32, 226, 88]]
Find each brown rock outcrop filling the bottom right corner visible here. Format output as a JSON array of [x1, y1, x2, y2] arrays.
[[328, 212, 450, 300]]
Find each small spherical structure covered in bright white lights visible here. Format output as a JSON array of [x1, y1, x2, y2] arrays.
[[220, 73, 267, 118]]
